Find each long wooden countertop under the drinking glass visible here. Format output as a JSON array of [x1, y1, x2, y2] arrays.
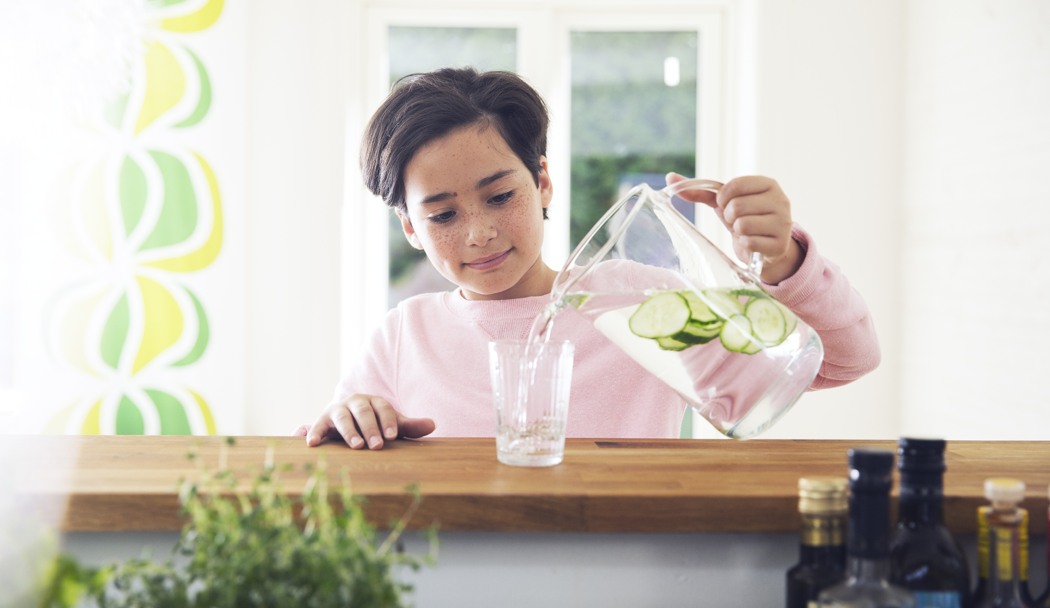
[[7, 436, 1050, 533]]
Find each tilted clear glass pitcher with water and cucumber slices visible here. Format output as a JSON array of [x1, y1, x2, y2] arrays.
[[538, 180, 823, 439]]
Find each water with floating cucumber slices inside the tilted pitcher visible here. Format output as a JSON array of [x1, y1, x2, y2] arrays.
[[530, 288, 821, 439]]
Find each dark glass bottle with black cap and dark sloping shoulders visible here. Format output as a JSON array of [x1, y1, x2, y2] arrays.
[[889, 437, 970, 608]]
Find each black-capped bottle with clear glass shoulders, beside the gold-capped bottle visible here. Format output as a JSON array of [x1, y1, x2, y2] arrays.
[[818, 448, 915, 608]]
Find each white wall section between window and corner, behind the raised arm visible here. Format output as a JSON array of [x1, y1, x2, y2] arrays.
[[740, 0, 904, 438]]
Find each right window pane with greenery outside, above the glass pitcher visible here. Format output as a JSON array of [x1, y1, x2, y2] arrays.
[[569, 32, 697, 246]]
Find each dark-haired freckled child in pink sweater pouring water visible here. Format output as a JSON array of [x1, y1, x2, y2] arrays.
[[296, 68, 880, 449]]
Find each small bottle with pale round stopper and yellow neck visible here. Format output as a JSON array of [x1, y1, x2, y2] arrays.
[[977, 478, 1035, 608]]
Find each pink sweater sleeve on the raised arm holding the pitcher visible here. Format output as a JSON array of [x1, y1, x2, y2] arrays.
[[764, 225, 882, 390]]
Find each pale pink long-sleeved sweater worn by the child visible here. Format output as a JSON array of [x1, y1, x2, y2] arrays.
[[336, 227, 880, 438]]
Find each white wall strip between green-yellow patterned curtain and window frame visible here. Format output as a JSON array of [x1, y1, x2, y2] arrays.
[[245, 0, 356, 435]]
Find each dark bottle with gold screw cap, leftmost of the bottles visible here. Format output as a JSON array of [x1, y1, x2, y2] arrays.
[[786, 477, 847, 608]]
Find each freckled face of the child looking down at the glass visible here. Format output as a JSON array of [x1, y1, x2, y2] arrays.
[[398, 125, 554, 299]]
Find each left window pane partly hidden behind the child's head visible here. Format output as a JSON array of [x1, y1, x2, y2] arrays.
[[387, 27, 518, 307]]
